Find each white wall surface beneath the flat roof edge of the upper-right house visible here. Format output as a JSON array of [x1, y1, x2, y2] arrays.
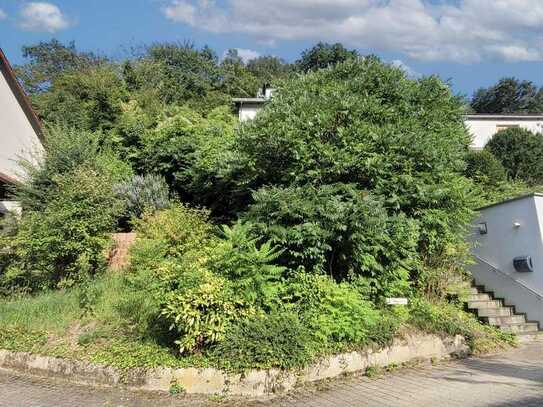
[[464, 117, 543, 150]]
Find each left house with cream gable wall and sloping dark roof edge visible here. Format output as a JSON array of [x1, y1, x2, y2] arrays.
[[0, 49, 43, 214]]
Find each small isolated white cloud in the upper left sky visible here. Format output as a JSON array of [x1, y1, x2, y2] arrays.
[[19, 2, 70, 33]]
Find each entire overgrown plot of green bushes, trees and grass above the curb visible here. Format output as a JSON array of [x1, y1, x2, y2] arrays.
[[0, 46, 525, 370]]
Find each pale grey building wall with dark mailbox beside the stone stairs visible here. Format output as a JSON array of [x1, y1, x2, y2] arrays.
[[470, 194, 543, 326]]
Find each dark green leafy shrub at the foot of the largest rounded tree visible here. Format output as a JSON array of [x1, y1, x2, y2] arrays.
[[244, 184, 418, 295]]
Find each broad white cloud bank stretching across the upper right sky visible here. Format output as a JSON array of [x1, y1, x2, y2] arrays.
[[163, 0, 543, 62]]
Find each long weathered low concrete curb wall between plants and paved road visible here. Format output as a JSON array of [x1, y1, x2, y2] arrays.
[[0, 335, 469, 397]]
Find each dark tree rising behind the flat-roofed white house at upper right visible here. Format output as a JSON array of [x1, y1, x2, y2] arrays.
[[471, 78, 543, 113]]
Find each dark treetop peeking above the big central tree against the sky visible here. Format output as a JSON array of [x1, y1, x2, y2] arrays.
[[296, 42, 359, 72]]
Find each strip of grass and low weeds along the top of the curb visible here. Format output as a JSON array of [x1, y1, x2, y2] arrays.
[[0, 274, 514, 370]]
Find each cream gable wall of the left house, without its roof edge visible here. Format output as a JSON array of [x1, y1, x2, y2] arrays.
[[0, 69, 43, 178]]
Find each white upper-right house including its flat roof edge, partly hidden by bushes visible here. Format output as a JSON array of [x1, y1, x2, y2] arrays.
[[464, 114, 543, 150]]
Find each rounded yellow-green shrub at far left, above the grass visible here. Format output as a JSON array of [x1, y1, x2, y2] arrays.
[[0, 167, 122, 291]]
